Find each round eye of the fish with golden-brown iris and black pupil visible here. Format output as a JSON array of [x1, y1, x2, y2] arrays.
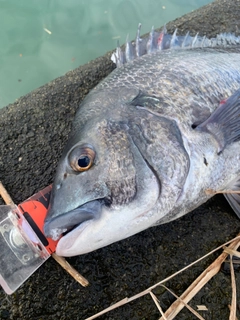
[[69, 146, 95, 172]]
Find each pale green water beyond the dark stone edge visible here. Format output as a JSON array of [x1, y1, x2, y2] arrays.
[[0, 0, 212, 108]]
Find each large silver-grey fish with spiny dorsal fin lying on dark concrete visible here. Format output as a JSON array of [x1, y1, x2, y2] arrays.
[[44, 26, 240, 256]]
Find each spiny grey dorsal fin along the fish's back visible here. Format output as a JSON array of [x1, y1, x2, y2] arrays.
[[111, 23, 240, 67]]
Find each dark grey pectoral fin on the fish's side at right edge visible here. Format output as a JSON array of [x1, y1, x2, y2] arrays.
[[195, 89, 240, 154]]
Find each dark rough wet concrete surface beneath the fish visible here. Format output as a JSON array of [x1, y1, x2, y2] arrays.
[[0, 0, 240, 320]]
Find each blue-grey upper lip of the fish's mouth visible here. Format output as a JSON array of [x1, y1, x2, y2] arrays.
[[44, 199, 103, 240]]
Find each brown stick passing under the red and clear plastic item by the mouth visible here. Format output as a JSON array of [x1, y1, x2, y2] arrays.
[[0, 181, 89, 287]]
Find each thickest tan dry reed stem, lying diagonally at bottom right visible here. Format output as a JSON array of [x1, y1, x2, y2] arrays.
[[161, 234, 240, 320]]
